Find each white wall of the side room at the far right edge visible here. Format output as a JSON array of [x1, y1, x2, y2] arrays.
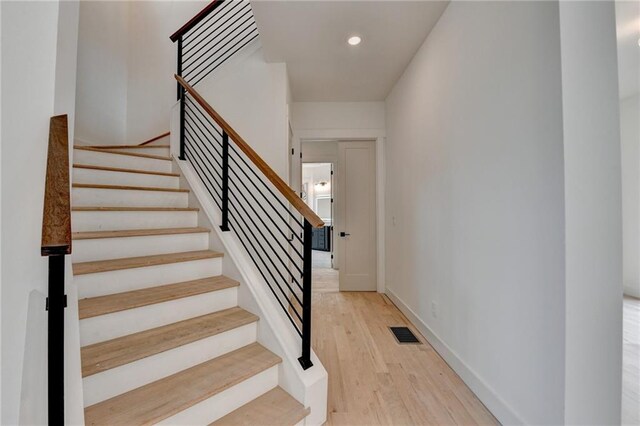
[[620, 94, 640, 297]]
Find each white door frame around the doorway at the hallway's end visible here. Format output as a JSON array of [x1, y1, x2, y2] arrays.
[[290, 129, 386, 293]]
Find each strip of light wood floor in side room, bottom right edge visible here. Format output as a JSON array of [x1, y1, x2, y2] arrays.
[[622, 296, 640, 425]]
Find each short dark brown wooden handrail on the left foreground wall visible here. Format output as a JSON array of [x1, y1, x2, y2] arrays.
[[40, 114, 71, 256]]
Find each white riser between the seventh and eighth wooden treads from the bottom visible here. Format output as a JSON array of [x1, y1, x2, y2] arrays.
[[72, 188, 189, 207]]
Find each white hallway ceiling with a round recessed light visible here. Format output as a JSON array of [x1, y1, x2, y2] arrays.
[[251, 0, 448, 101]]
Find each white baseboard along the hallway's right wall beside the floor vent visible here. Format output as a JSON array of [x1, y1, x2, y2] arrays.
[[386, 287, 527, 425]]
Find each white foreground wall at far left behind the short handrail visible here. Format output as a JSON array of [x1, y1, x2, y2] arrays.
[[0, 1, 78, 424]]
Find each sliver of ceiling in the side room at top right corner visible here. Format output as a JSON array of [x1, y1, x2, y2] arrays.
[[616, 0, 640, 98]]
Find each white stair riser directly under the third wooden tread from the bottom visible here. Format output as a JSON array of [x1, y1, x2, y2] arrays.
[[83, 322, 258, 407]]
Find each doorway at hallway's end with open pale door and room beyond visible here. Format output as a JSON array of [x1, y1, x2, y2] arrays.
[[301, 140, 378, 292]]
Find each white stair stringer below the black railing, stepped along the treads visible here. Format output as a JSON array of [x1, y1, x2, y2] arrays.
[[172, 157, 328, 426]]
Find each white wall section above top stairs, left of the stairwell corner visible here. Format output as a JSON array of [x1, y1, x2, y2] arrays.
[[75, 1, 130, 145]]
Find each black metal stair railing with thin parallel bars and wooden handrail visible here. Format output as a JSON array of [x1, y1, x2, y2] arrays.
[[171, 1, 322, 369]]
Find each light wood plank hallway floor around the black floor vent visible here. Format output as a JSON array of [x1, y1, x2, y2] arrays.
[[312, 291, 498, 426]]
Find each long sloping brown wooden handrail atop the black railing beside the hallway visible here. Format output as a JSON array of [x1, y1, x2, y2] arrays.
[[174, 74, 324, 228]]
